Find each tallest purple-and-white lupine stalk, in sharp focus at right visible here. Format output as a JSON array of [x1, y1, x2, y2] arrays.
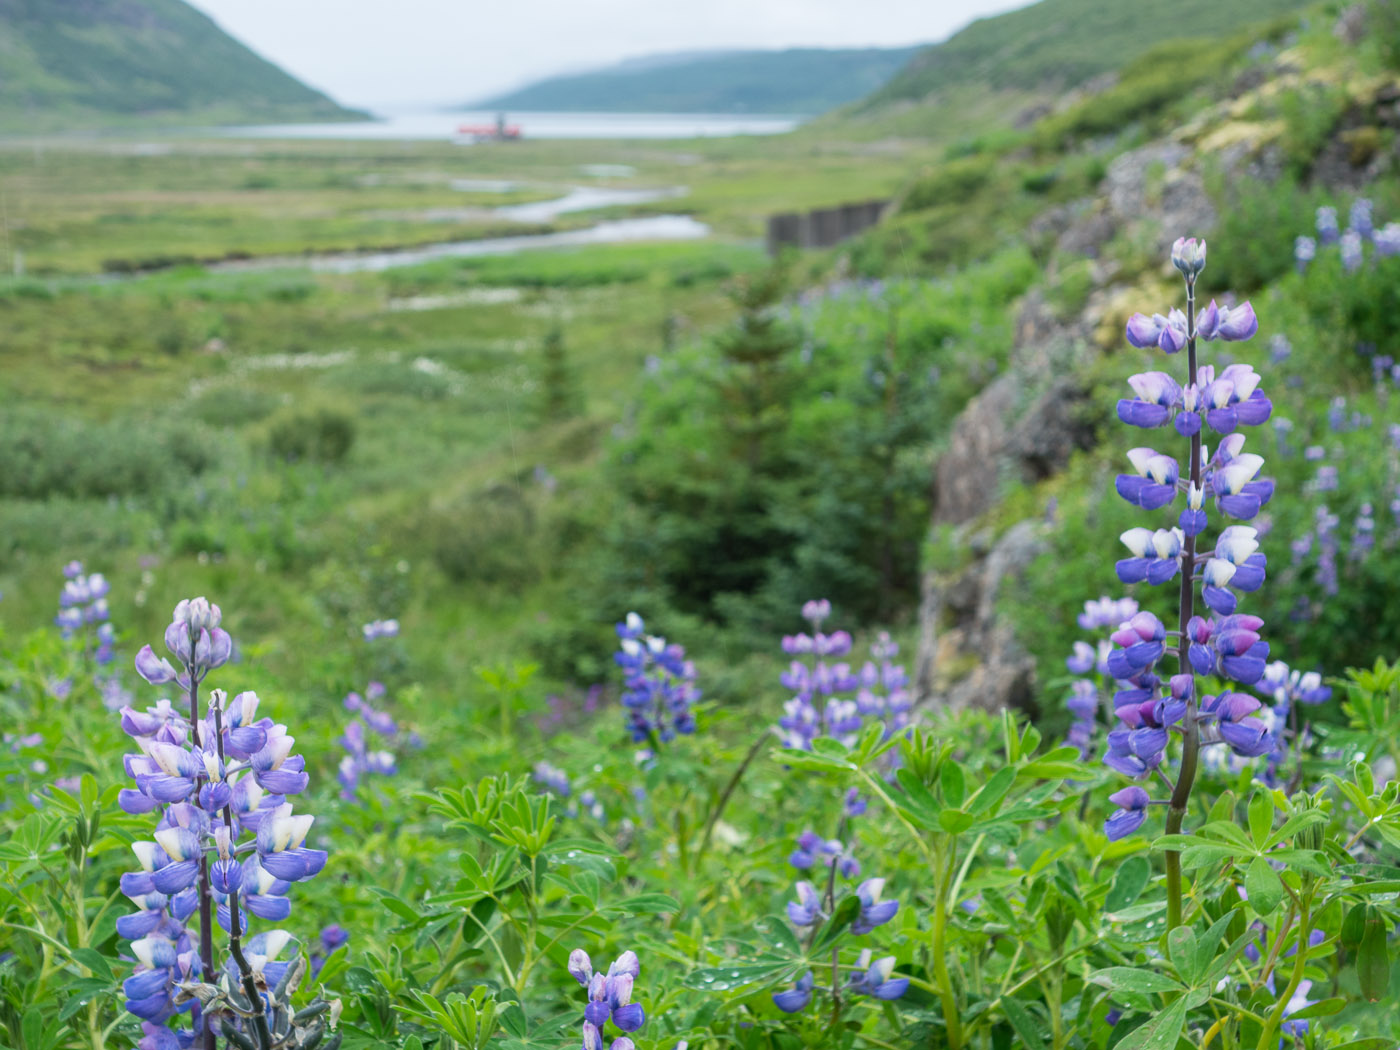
[[1105, 238, 1274, 928]]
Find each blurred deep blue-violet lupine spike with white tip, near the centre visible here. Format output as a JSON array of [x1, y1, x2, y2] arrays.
[[613, 613, 700, 743]]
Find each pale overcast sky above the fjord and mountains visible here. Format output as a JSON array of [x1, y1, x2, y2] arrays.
[[190, 0, 1028, 106]]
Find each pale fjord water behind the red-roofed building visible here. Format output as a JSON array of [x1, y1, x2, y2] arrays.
[[216, 111, 801, 141]]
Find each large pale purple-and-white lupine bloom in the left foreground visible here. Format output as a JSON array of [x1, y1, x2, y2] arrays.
[[118, 598, 326, 1047]]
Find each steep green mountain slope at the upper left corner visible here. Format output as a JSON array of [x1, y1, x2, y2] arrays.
[[0, 0, 364, 132]]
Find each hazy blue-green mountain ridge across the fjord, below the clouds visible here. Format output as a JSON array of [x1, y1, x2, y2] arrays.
[[466, 48, 918, 115]]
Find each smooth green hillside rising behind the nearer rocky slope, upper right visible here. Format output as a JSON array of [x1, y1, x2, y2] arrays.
[[862, 0, 1306, 108]]
